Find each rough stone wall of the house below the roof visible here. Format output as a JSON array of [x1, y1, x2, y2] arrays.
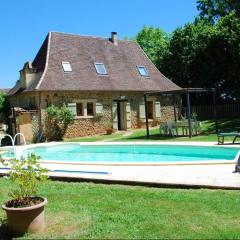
[[7, 91, 180, 141]]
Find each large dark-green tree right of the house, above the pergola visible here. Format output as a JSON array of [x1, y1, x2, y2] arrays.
[[162, 17, 240, 102]]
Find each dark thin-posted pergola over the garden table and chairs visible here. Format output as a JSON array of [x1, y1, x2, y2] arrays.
[[144, 88, 218, 138]]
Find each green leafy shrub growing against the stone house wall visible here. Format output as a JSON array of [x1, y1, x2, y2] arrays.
[[45, 105, 74, 141]]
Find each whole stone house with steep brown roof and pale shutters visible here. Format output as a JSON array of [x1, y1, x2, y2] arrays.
[[8, 32, 181, 141]]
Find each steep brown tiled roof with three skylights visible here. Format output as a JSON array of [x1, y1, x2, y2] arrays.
[[8, 32, 180, 94]]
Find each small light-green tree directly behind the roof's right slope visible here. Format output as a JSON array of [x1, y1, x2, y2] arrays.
[[135, 26, 170, 67]]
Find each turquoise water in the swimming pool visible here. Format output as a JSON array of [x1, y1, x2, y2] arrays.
[[3, 144, 240, 162]]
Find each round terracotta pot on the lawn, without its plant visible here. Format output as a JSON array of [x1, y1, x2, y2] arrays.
[[2, 197, 47, 235]]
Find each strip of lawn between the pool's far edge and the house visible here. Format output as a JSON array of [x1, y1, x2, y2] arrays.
[[64, 119, 240, 142]]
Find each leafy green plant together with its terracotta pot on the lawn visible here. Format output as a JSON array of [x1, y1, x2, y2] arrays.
[[0, 154, 48, 235]]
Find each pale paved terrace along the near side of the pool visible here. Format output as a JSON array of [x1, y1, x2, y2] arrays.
[[0, 142, 240, 189]]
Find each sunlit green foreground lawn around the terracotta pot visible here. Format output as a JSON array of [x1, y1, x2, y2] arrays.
[[0, 178, 240, 239]]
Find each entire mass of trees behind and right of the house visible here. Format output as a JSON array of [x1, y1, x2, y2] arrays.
[[133, 0, 240, 102]]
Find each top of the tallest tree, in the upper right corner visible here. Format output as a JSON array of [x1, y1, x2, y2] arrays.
[[197, 0, 240, 23]]
